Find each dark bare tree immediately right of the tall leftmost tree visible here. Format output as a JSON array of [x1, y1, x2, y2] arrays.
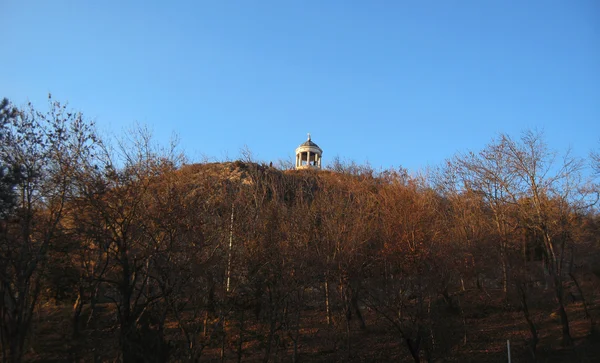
[[70, 128, 182, 361]]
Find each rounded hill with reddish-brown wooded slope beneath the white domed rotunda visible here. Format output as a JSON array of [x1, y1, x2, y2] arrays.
[[7, 161, 600, 362]]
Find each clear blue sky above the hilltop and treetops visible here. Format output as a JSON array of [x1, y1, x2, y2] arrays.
[[0, 0, 600, 170]]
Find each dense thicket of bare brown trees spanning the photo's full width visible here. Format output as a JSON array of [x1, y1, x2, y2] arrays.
[[0, 97, 600, 362]]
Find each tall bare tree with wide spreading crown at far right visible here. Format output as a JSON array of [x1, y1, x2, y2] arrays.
[[458, 131, 588, 345]]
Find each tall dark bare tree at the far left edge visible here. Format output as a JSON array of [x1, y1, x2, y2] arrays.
[[0, 97, 97, 362]]
